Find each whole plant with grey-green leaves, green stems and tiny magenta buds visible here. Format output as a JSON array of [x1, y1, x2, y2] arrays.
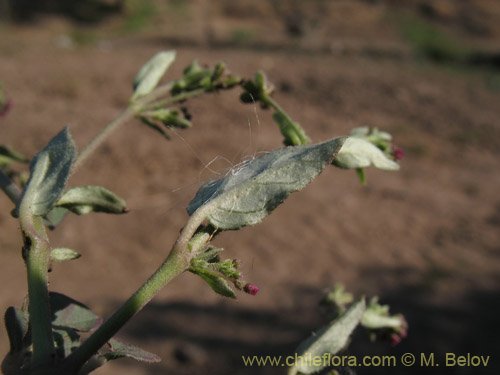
[[0, 51, 407, 375]]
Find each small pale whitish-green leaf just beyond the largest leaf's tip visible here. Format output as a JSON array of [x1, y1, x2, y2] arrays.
[[333, 137, 399, 171]]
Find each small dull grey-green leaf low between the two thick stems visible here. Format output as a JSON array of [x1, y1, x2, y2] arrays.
[[50, 292, 102, 331]]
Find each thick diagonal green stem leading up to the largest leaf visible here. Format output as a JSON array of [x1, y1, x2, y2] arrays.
[[63, 207, 211, 373]]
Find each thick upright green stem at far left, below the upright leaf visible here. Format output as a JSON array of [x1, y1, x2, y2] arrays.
[[19, 213, 55, 368]]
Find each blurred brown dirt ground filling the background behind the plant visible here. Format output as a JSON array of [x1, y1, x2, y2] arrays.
[[0, 0, 500, 375]]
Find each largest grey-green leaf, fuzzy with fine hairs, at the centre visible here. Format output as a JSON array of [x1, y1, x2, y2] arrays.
[[187, 137, 345, 230]]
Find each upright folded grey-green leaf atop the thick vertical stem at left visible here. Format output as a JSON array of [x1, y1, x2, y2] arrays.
[[19, 127, 76, 216]]
